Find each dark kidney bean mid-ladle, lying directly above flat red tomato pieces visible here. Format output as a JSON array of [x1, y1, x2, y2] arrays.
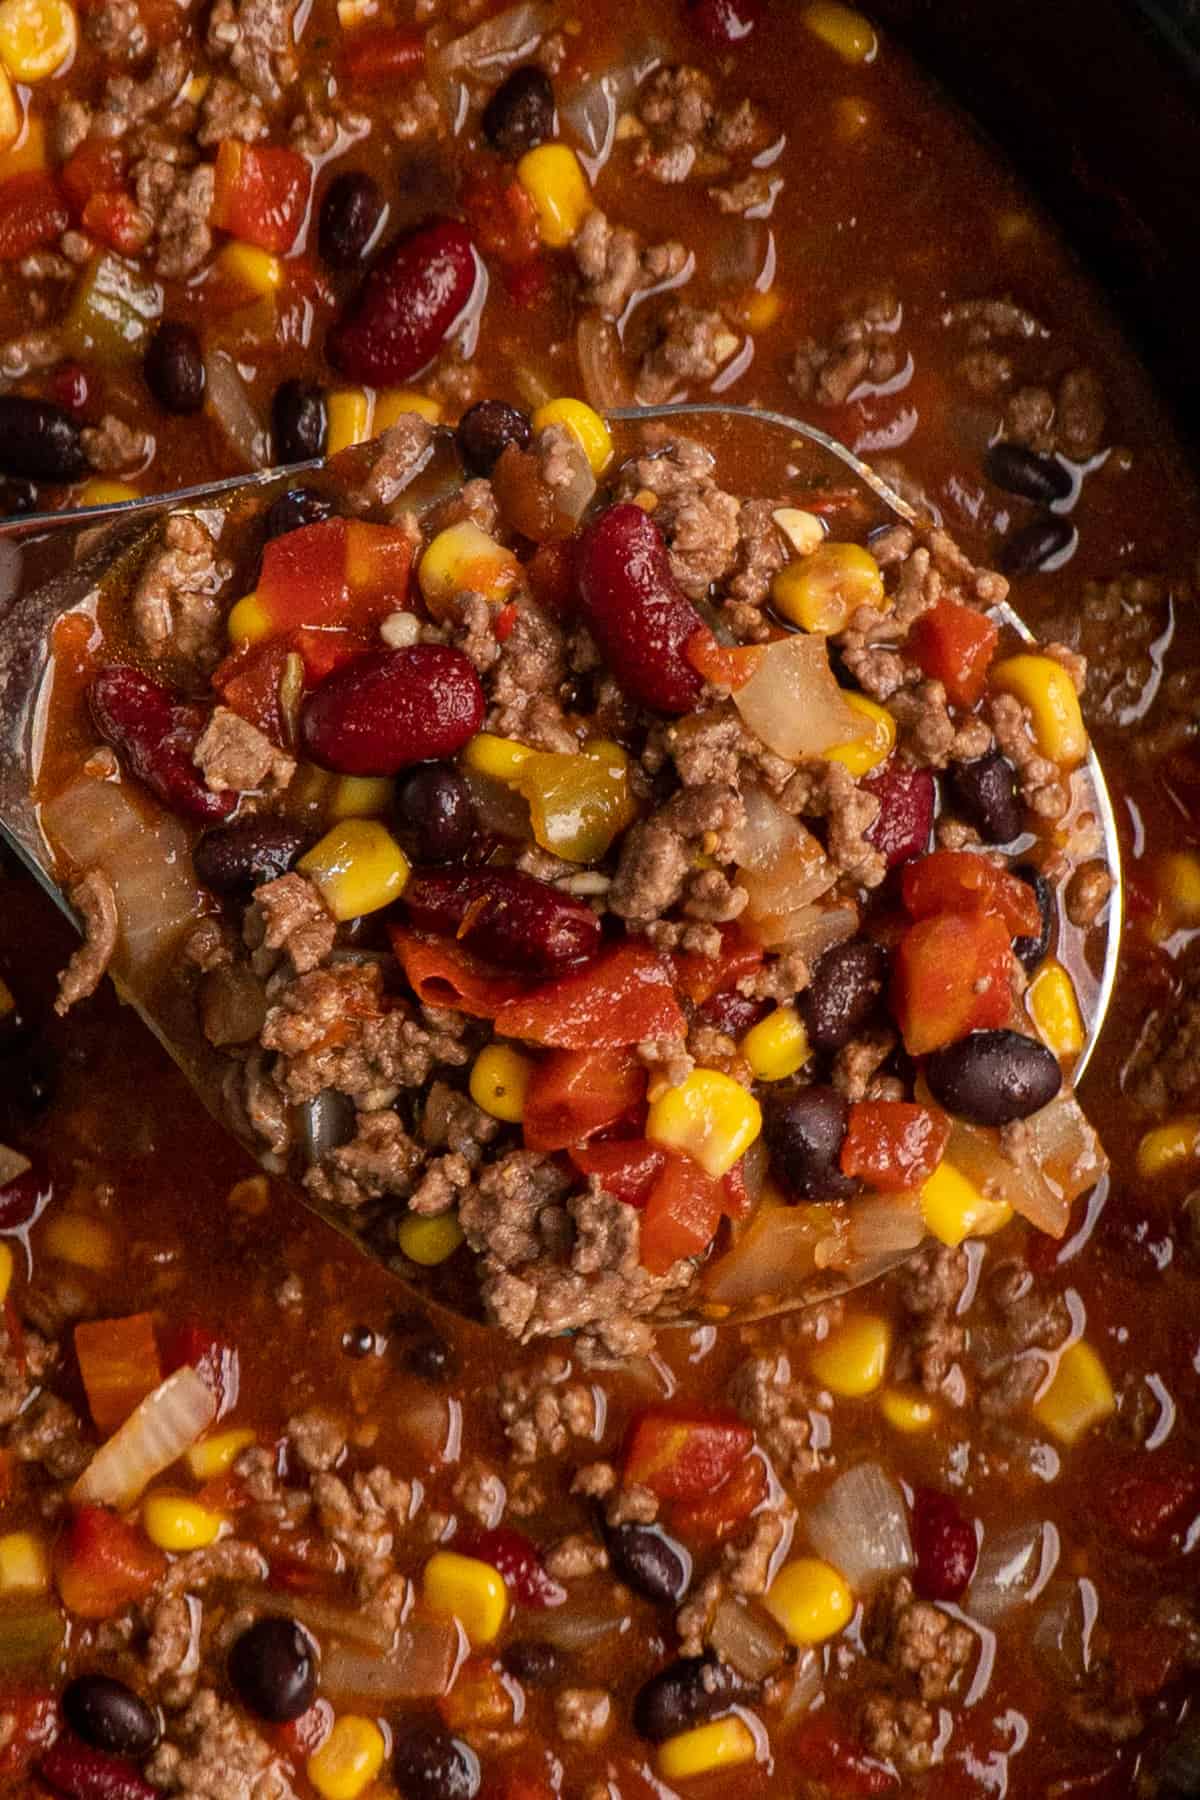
[[403, 869, 601, 976]]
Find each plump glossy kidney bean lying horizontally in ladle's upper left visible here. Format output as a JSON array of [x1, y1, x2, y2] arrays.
[[300, 644, 484, 776]]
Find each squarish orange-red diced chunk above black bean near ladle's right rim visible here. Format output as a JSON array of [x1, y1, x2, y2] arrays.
[[891, 913, 1013, 1057]]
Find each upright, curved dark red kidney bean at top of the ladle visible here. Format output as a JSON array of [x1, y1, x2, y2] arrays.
[[576, 504, 703, 713]]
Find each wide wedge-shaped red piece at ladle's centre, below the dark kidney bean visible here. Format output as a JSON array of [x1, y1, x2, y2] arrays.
[[497, 943, 685, 1049]]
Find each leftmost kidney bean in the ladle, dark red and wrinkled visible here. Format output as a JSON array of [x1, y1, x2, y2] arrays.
[[88, 662, 237, 819]]
